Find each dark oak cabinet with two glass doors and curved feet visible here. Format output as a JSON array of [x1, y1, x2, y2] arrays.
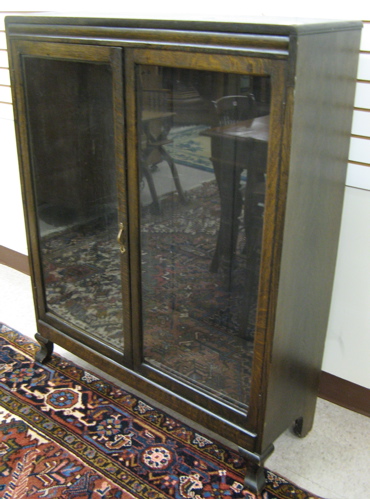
[[6, 17, 361, 491]]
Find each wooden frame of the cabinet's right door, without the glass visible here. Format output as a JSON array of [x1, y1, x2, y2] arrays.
[[125, 48, 287, 431]]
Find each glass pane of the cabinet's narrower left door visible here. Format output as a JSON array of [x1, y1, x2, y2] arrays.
[[24, 57, 123, 350]]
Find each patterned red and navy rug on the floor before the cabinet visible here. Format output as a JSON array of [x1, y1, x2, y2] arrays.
[[0, 324, 317, 499]]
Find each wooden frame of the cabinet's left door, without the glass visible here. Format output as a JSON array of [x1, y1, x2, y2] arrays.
[[11, 40, 132, 367]]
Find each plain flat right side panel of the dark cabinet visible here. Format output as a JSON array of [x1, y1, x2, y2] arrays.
[[263, 27, 360, 447]]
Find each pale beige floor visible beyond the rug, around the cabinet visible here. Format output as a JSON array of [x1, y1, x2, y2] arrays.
[[0, 265, 370, 499]]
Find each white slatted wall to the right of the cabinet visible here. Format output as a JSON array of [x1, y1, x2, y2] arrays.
[[322, 20, 370, 388]]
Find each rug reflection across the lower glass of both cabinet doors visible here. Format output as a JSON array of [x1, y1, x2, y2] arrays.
[[41, 181, 258, 408]]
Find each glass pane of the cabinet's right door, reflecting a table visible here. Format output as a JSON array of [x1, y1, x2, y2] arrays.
[[137, 66, 270, 408]]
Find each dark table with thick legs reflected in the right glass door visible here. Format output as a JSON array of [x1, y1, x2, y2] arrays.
[[201, 116, 270, 279]]
